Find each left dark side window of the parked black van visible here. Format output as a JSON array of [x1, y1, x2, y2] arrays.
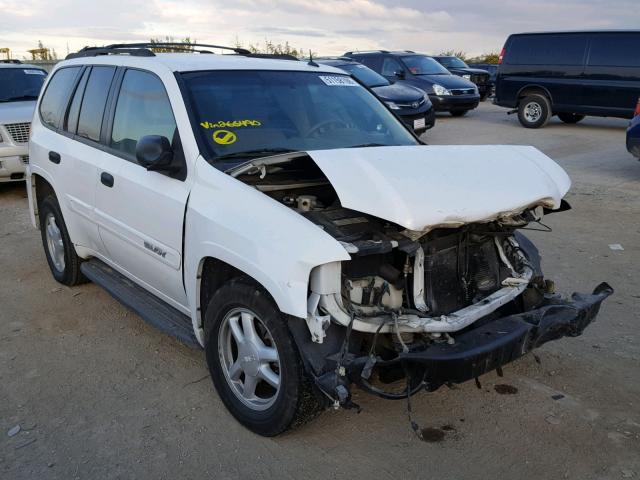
[[505, 34, 587, 65]]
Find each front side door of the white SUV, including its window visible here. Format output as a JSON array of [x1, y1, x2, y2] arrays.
[[96, 69, 189, 308]]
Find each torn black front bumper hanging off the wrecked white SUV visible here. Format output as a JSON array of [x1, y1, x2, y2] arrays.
[[292, 283, 613, 405]]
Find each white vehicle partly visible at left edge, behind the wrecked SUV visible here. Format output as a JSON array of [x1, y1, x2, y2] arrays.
[[0, 61, 47, 182]]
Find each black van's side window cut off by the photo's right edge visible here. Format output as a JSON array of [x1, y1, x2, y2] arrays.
[[589, 33, 640, 67]]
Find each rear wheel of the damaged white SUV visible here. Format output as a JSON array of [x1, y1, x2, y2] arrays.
[[38, 195, 87, 287]]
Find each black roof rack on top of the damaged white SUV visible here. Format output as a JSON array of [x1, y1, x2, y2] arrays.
[[66, 42, 251, 60]]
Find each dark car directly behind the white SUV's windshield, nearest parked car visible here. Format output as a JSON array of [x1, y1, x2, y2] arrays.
[[314, 57, 436, 135]]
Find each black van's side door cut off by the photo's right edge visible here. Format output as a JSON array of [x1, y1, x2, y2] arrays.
[[584, 32, 640, 118]]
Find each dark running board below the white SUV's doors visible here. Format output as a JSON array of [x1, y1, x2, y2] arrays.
[[80, 258, 201, 348]]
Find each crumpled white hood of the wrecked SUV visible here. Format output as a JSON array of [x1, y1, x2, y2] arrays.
[[307, 145, 571, 231]]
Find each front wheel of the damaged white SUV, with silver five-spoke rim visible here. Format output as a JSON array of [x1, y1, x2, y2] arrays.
[[205, 279, 321, 436]]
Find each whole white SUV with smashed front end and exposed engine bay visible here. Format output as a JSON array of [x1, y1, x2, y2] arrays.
[[29, 45, 612, 435]]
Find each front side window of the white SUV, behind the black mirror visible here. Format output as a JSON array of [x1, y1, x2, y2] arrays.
[[109, 70, 177, 157]]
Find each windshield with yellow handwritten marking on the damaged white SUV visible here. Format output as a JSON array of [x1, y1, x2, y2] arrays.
[[182, 70, 418, 164]]
